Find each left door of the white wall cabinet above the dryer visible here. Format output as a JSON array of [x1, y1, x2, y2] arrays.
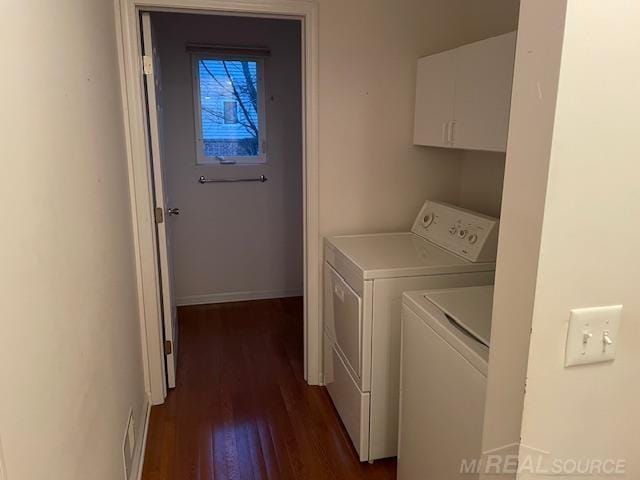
[[413, 51, 456, 147]]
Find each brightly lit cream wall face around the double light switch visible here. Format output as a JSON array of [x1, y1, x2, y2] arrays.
[[522, 0, 640, 479]]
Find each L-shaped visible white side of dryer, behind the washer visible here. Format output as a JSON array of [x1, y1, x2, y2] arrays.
[[365, 272, 494, 459]]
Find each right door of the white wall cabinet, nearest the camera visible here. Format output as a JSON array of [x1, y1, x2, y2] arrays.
[[453, 32, 516, 152]]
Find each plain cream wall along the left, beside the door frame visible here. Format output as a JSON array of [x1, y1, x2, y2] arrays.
[[0, 0, 146, 480]]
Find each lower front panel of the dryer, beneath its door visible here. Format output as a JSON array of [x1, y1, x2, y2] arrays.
[[324, 335, 370, 462]]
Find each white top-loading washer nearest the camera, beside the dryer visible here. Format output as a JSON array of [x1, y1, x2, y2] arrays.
[[398, 286, 493, 480]]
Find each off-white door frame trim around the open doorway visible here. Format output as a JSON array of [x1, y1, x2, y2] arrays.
[[114, 0, 322, 405]]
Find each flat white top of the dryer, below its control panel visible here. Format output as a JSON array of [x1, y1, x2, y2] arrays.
[[326, 232, 495, 279]]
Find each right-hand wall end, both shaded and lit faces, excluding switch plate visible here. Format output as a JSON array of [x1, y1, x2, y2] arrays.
[[484, 0, 640, 478]]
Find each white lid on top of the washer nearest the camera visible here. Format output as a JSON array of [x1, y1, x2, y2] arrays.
[[424, 286, 493, 347]]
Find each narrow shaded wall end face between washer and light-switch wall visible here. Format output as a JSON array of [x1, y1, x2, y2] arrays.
[[483, 0, 564, 479]]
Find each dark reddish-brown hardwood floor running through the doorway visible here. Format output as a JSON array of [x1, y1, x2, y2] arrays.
[[143, 298, 396, 480]]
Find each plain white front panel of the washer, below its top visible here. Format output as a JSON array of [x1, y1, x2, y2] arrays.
[[398, 309, 486, 480]]
